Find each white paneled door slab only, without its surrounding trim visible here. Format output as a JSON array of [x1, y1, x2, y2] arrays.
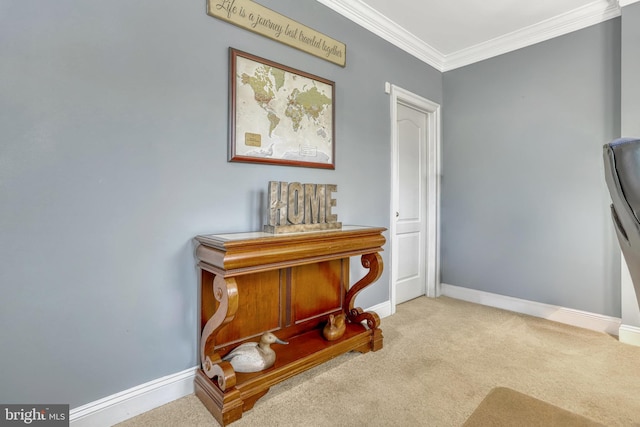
[[394, 103, 428, 303]]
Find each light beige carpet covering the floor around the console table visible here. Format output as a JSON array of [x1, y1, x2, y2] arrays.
[[121, 297, 640, 427]]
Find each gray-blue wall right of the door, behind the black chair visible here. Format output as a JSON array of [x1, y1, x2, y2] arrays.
[[441, 19, 620, 317]]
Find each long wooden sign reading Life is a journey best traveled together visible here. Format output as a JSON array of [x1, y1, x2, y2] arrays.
[[207, 0, 347, 67]]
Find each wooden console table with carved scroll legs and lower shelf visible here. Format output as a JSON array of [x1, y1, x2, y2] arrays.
[[195, 226, 385, 425]]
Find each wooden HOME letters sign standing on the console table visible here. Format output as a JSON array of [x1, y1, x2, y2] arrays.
[[264, 181, 342, 234]]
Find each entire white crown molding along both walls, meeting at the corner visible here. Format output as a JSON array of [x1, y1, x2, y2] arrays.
[[317, 0, 620, 72]]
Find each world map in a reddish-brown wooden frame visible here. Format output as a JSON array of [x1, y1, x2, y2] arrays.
[[229, 48, 335, 169]]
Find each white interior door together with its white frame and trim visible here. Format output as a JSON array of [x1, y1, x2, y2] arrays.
[[390, 86, 440, 312]]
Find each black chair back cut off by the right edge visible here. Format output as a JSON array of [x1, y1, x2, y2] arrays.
[[603, 138, 640, 306]]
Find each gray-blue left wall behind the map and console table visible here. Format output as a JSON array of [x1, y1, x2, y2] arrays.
[[0, 0, 442, 408]]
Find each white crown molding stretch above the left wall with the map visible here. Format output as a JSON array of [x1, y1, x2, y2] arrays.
[[317, 0, 445, 71]]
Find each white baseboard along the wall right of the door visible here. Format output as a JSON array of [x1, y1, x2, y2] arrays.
[[441, 283, 620, 338]]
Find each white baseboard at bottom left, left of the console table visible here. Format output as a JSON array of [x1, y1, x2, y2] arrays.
[[69, 367, 198, 427]]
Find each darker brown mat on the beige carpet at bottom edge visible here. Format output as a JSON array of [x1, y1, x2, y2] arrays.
[[463, 387, 604, 427]]
